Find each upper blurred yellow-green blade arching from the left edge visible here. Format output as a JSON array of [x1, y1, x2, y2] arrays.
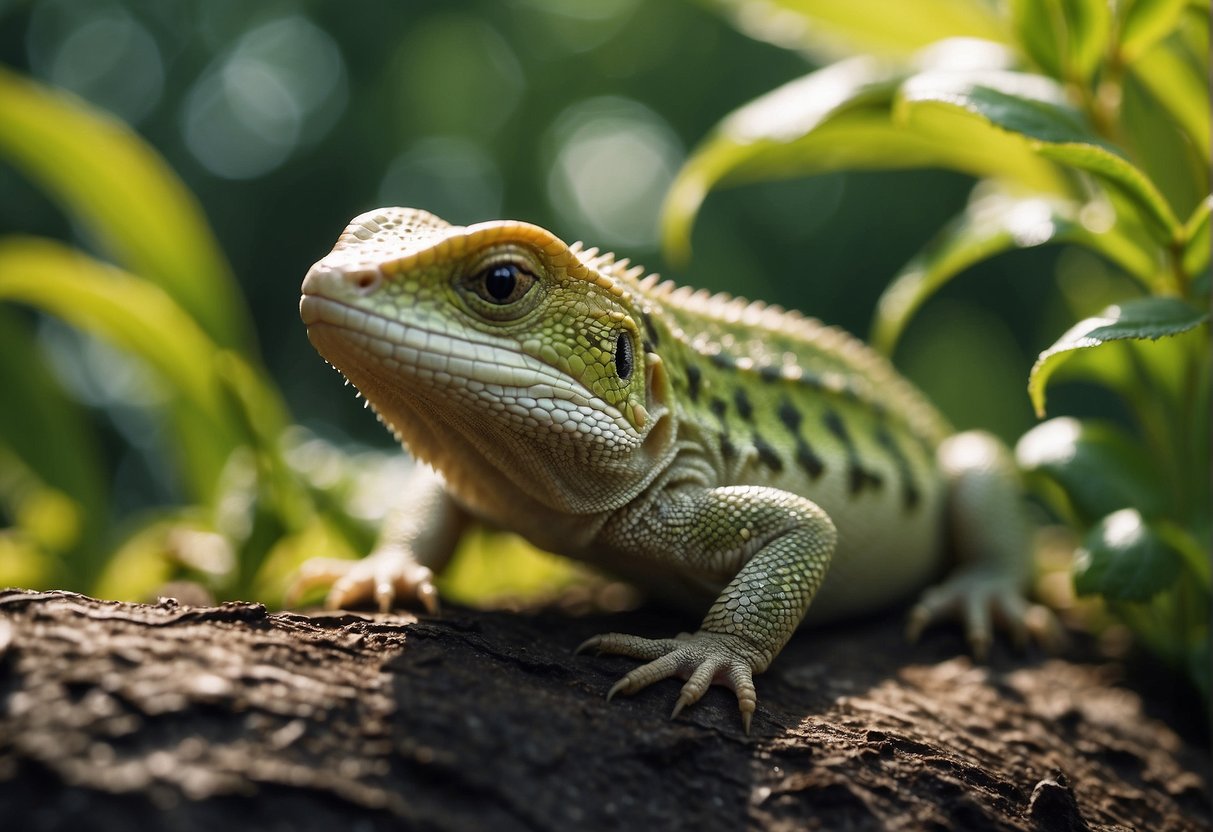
[[0, 68, 252, 349]]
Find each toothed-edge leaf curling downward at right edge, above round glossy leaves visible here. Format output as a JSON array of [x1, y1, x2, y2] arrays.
[[1027, 297, 1209, 416]]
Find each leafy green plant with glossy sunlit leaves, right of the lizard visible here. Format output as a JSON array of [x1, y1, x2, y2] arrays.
[[664, 0, 1213, 695]]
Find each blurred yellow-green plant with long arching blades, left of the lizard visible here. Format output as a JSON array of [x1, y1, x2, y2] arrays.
[[0, 69, 397, 606]]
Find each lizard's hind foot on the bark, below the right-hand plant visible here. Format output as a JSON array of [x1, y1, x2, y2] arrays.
[[906, 569, 1064, 659]]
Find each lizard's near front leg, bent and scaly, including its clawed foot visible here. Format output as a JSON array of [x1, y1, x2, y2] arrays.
[[577, 486, 837, 734]]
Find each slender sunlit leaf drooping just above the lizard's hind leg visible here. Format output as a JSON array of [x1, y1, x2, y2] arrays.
[[872, 183, 1156, 354]]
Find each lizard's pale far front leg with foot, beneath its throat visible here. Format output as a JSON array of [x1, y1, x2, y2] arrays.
[[286, 465, 471, 612]]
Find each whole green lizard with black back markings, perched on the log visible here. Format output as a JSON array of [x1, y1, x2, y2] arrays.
[[297, 207, 1052, 733]]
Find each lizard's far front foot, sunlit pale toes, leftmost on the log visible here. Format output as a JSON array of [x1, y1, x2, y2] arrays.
[[286, 549, 438, 615]]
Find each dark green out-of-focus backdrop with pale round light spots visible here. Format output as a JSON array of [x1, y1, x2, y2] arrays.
[[0, 0, 1065, 456]]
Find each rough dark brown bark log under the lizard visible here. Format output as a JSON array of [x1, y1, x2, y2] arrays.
[[0, 592, 1213, 832]]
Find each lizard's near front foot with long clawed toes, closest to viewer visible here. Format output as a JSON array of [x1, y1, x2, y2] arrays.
[[576, 629, 764, 734]]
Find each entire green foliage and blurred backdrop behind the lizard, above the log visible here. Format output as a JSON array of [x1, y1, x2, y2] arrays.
[[0, 0, 1209, 690]]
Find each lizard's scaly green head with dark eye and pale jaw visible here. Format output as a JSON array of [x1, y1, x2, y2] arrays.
[[300, 209, 673, 513]]
